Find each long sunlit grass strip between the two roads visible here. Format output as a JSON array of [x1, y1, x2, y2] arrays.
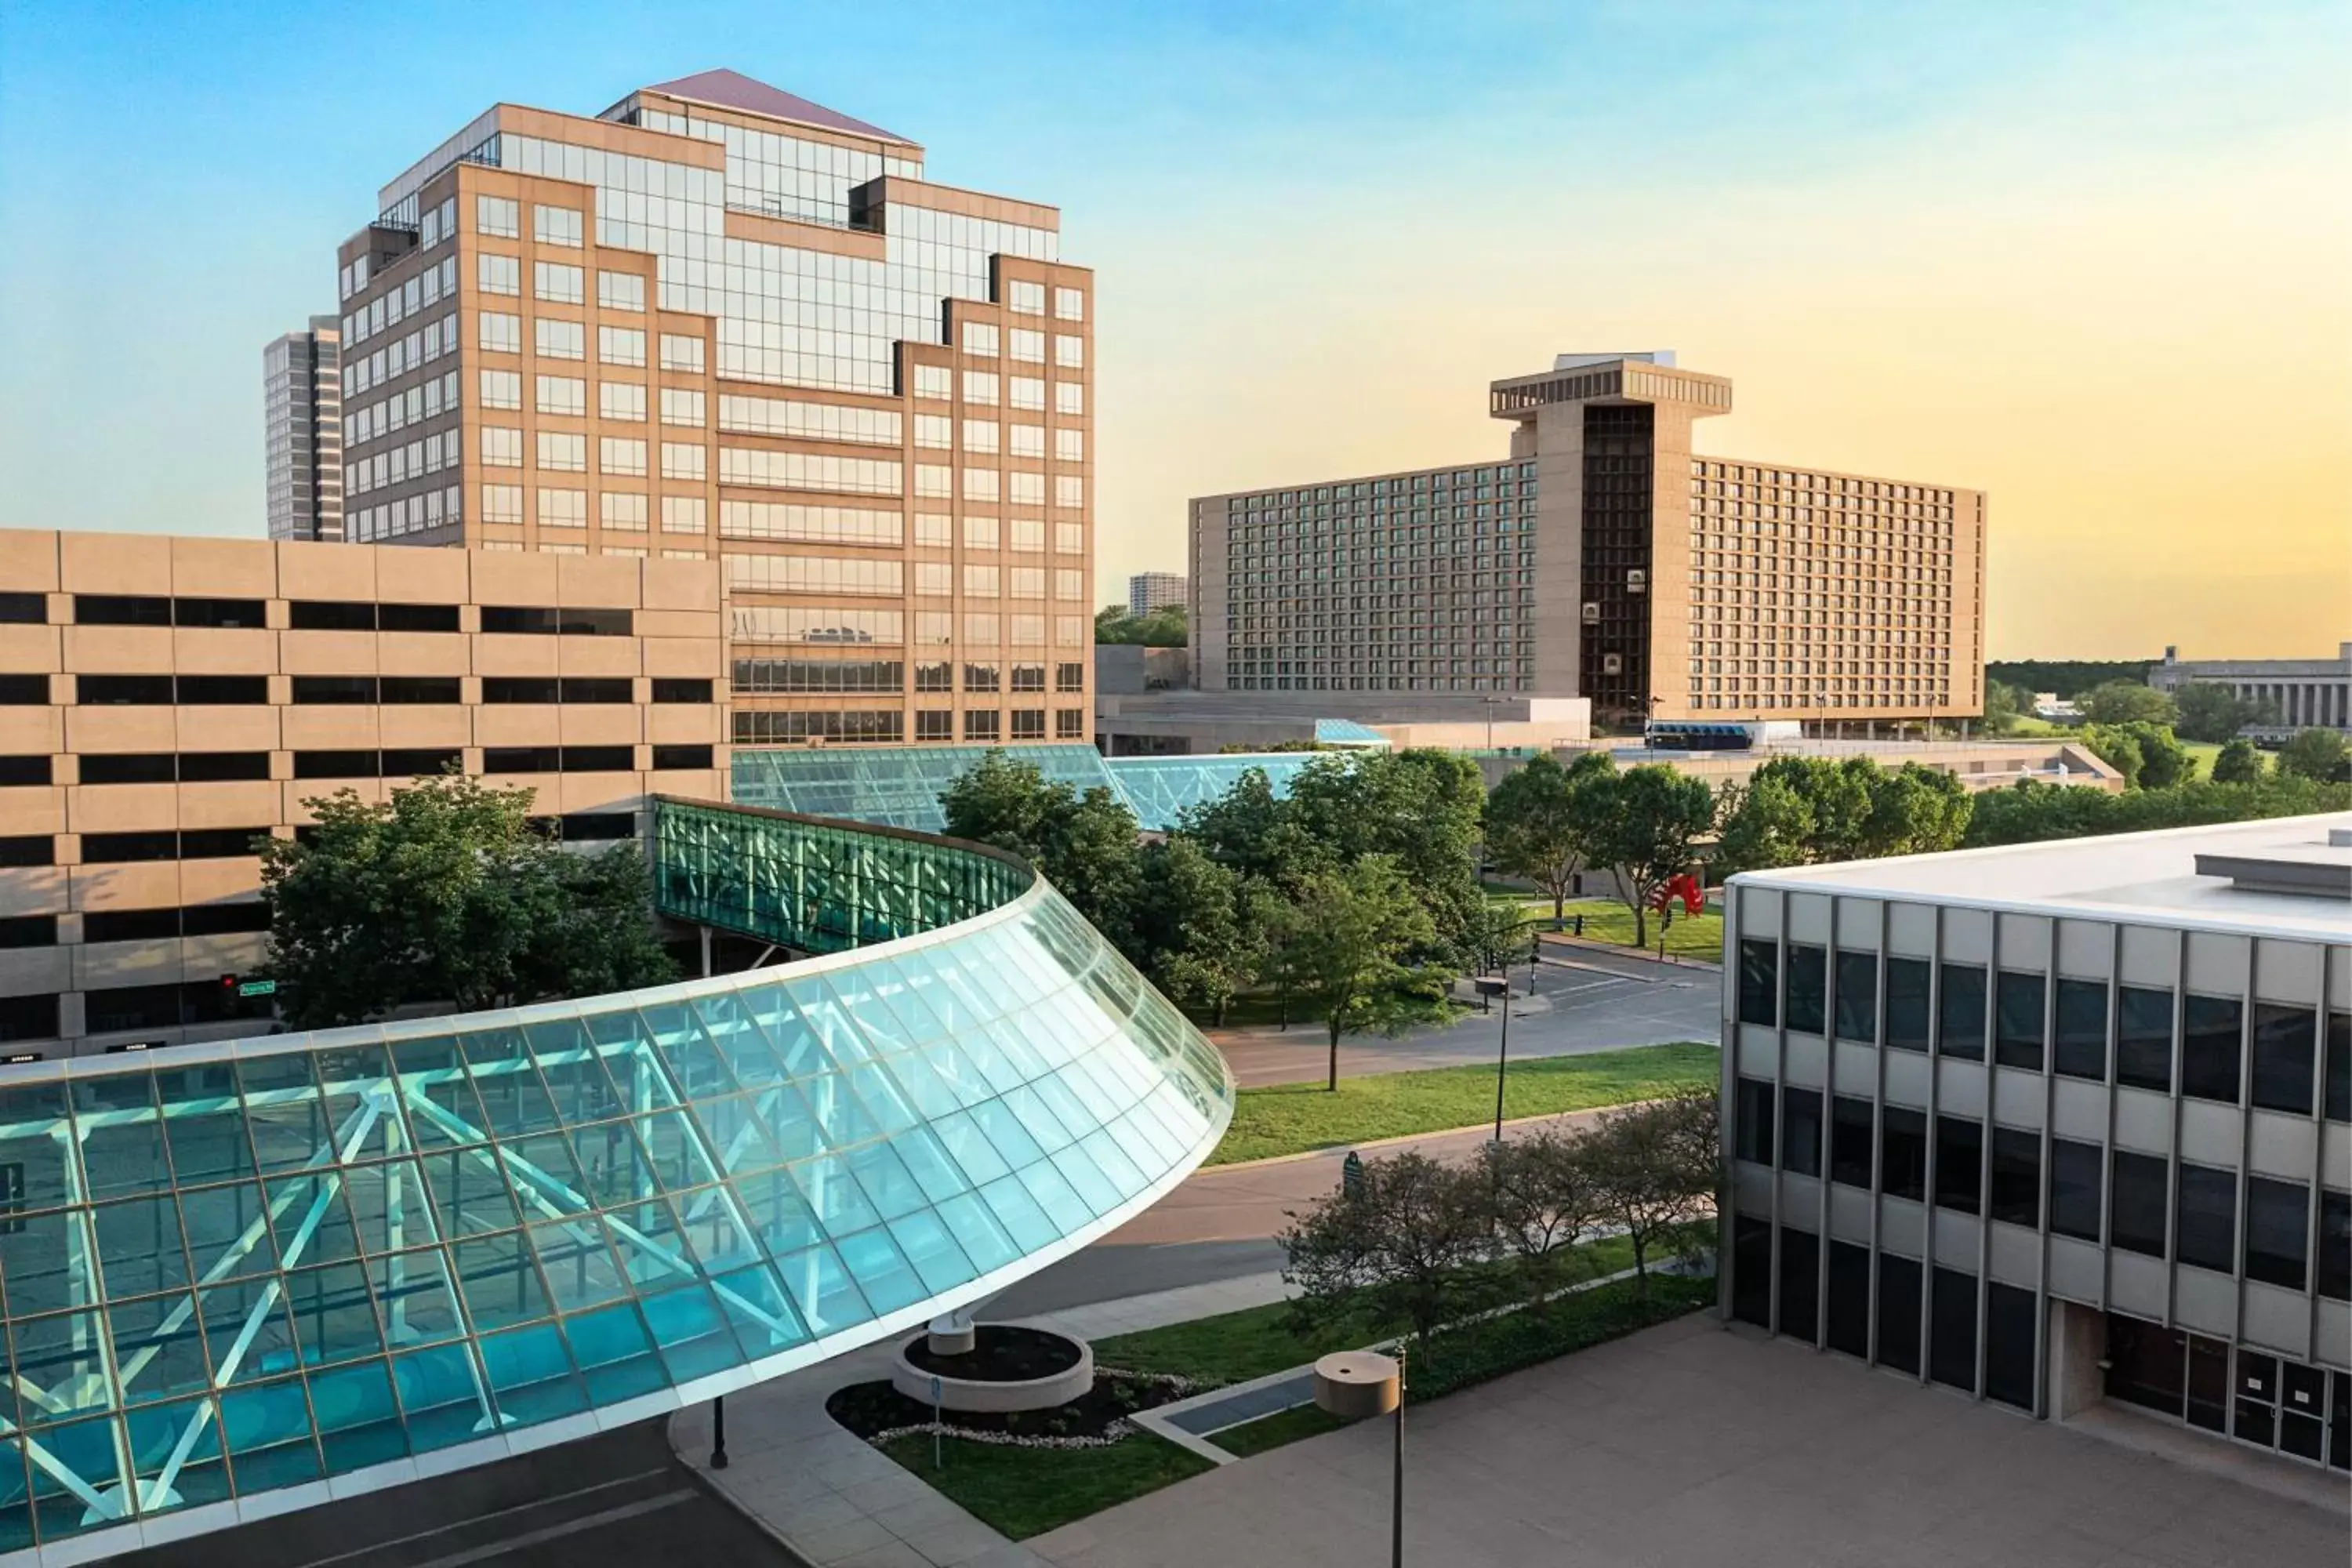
[[1209, 1041, 1722, 1166]]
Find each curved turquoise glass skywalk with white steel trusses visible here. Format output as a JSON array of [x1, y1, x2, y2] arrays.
[[0, 801, 1232, 1566]]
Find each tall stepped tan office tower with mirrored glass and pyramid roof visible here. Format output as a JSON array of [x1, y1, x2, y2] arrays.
[[339, 71, 1094, 746]]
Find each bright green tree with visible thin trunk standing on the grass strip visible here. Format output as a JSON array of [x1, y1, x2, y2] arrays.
[[1282, 855, 1449, 1091]]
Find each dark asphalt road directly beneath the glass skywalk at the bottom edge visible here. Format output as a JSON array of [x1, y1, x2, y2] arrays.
[[111, 1420, 804, 1568]]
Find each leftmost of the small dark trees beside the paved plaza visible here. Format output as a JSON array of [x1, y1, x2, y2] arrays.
[[1275, 1154, 1494, 1354]]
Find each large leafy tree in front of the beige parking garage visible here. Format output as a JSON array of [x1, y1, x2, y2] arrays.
[[261, 776, 675, 1029]]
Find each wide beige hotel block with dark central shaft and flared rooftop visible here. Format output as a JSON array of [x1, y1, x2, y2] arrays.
[[1190, 353, 1985, 727]]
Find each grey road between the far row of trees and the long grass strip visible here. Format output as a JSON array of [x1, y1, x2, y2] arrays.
[[1211, 947, 1722, 1088]]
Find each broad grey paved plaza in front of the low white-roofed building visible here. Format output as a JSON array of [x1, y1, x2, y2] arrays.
[[1028, 1314, 2347, 1568]]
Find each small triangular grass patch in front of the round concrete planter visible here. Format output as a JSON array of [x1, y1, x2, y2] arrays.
[[882, 1432, 1214, 1540]]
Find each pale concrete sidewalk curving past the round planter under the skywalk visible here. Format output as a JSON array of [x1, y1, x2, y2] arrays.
[[670, 1274, 1284, 1568]]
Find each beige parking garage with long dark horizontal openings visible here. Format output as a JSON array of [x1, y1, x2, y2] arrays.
[[0, 529, 729, 1060]]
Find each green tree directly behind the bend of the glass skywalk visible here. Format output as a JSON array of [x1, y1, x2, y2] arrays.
[[938, 750, 1141, 952]]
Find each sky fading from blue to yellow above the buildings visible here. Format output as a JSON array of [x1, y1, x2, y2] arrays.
[[0, 0, 2352, 659]]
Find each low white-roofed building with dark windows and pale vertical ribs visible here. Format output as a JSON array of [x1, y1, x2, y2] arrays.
[[1724, 815, 2352, 1472]]
